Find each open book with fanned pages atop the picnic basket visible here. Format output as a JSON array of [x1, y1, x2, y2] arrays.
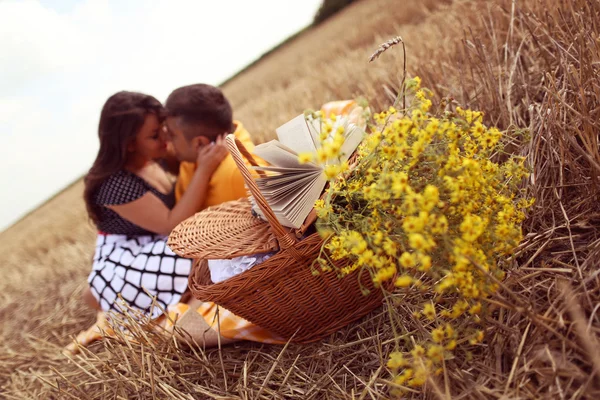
[[253, 114, 365, 228]]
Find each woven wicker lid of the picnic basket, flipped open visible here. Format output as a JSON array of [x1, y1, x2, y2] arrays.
[[168, 199, 279, 260]]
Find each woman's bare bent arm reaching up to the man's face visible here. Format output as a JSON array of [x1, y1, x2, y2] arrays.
[[107, 142, 227, 235]]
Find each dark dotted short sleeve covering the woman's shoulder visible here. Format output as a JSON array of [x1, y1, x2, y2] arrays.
[[95, 170, 148, 205]]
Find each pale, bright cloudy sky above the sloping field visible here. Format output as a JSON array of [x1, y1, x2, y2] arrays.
[[0, 0, 321, 231]]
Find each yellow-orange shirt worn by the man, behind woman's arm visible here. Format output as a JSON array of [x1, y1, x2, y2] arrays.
[[175, 121, 260, 211]]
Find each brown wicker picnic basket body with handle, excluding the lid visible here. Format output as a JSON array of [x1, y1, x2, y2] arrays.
[[180, 135, 383, 343]]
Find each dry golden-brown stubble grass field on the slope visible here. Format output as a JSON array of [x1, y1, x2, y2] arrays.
[[0, 0, 600, 399]]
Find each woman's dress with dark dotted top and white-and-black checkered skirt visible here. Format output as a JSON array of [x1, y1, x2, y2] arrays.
[[88, 171, 192, 318]]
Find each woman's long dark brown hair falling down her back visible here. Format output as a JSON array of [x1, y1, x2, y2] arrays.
[[83, 91, 163, 227]]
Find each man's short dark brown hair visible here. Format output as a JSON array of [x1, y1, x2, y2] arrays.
[[165, 83, 233, 139]]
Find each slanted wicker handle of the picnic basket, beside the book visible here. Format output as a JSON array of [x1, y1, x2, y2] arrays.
[[225, 133, 298, 249]]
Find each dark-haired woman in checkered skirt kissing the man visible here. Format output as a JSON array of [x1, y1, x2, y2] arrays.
[[84, 92, 227, 318]]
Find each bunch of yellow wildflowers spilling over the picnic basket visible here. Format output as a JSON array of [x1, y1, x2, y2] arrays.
[[300, 78, 532, 388]]
